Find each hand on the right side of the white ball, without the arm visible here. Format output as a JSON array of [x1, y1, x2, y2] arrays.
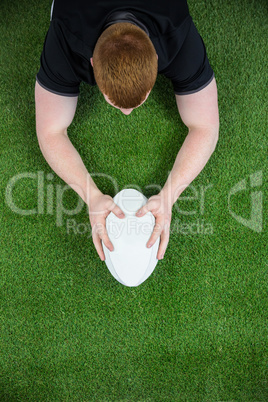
[[136, 192, 172, 260]]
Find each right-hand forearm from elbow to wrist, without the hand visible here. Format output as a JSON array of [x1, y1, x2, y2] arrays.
[[162, 127, 218, 205]]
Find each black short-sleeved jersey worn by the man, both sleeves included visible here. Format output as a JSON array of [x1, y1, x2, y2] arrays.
[[36, 0, 213, 96]]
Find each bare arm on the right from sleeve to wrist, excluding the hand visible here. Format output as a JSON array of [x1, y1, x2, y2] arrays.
[[163, 78, 219, 205]]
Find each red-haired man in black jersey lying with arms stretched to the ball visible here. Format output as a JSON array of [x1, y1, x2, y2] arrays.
[[35, 0, 219, 260]]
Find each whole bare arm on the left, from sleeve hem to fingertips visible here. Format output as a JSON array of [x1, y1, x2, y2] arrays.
[[35, 82, 124, 260]]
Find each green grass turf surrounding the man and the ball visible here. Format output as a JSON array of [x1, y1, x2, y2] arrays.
[[0, 0, 268, 402]]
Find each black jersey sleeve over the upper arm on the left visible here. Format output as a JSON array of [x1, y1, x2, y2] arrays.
[[36, 21, 81, 96]]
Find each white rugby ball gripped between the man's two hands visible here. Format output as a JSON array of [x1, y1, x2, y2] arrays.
[[102, 189, 160, 287]]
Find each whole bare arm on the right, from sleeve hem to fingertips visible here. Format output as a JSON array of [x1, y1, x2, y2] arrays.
[[137, 79, 219, 259]]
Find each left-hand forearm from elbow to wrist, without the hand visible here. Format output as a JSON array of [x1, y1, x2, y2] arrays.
[[37, 132, 99, 204]]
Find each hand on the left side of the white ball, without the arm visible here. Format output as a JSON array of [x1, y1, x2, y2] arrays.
[[88, 191, 125, 261]]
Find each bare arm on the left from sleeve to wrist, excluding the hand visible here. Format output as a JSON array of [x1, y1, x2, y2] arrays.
[[35, 82, 97, 202]]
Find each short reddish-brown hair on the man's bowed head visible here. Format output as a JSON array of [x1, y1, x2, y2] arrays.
[[93, 22, 158, 109]]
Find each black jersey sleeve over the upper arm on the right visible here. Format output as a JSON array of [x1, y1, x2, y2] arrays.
[[161, 22, 214, 95]]
